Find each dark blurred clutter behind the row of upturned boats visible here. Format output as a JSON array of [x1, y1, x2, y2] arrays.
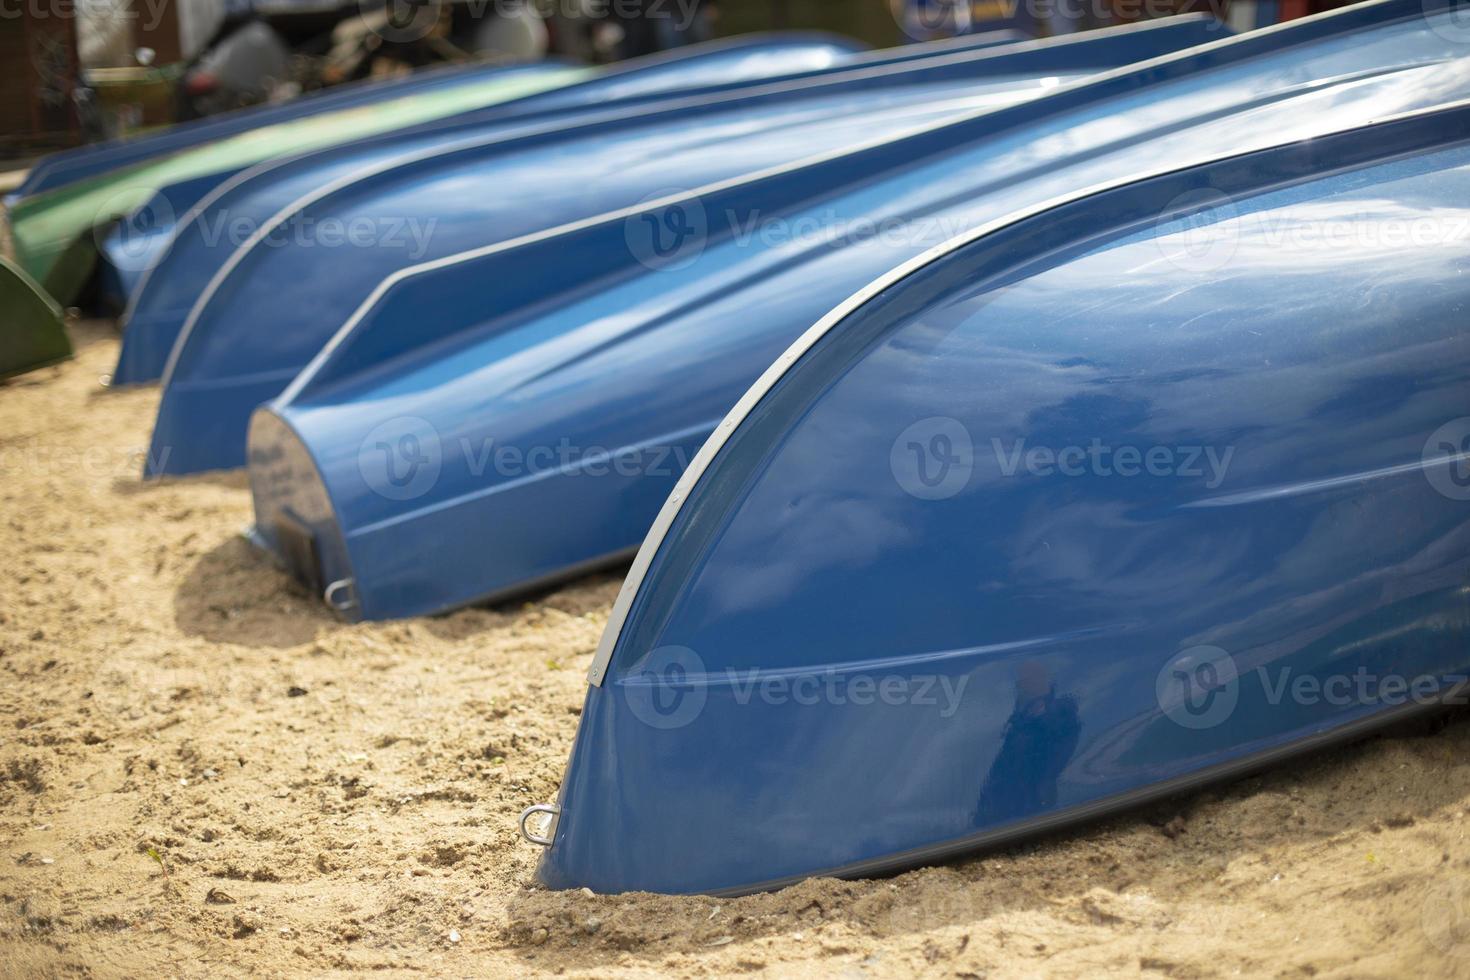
[[0, 0, 1341, 163]]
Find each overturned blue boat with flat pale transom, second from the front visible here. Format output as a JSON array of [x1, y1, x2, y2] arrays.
[[246, 0, 1470, 628]]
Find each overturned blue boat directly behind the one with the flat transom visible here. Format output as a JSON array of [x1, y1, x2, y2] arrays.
[[152, 19, 1220, 473]]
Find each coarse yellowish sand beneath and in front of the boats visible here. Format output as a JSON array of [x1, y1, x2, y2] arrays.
[[0, 325, 1470, 979]]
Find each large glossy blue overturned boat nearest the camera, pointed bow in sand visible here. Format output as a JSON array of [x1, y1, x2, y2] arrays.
[[532, 103, 1470, 893]]
